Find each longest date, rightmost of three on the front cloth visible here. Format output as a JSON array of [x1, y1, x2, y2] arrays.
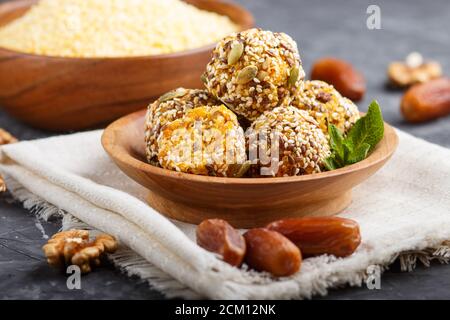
[[267, 217, 361, 257]]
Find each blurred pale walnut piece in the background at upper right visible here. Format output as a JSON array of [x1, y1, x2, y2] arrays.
[[388, 52, 442, 87]]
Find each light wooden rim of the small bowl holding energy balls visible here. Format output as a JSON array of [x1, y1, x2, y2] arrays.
[[101, 109, 399, 186]]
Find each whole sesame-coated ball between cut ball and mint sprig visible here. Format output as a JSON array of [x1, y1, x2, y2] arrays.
[[246, 106, 330, 177]]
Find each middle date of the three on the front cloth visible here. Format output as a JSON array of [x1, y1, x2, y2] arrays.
[[244, 228, 302, 277]]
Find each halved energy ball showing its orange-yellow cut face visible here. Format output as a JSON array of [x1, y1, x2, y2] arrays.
[[158, 105, 247, 177]]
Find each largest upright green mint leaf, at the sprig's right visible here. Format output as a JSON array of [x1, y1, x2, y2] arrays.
[[346, 100, 384, 152]]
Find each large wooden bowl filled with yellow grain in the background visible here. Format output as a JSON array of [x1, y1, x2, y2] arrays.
[[0, 0, 253, 131]]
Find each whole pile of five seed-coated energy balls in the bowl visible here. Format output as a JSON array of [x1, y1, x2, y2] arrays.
[[145, 29, 359, 177]]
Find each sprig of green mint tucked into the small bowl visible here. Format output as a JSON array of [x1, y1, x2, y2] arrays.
[[324, 100, 384, 170]]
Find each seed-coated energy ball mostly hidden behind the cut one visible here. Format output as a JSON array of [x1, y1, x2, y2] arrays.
[[145, 88, 218, 163]]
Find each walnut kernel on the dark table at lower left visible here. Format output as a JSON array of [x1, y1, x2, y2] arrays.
[[42, 230, 117, 273]]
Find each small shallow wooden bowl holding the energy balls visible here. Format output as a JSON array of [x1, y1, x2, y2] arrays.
[[102, 110, 398, 228]]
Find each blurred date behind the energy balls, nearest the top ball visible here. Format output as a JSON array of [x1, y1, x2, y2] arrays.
[[311, 58, 366, 101]]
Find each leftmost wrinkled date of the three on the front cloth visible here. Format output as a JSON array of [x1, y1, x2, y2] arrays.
[[196, 219, 246, 267]]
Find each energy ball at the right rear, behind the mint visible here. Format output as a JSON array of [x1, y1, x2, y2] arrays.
[[292, 80, 360, 135]]
